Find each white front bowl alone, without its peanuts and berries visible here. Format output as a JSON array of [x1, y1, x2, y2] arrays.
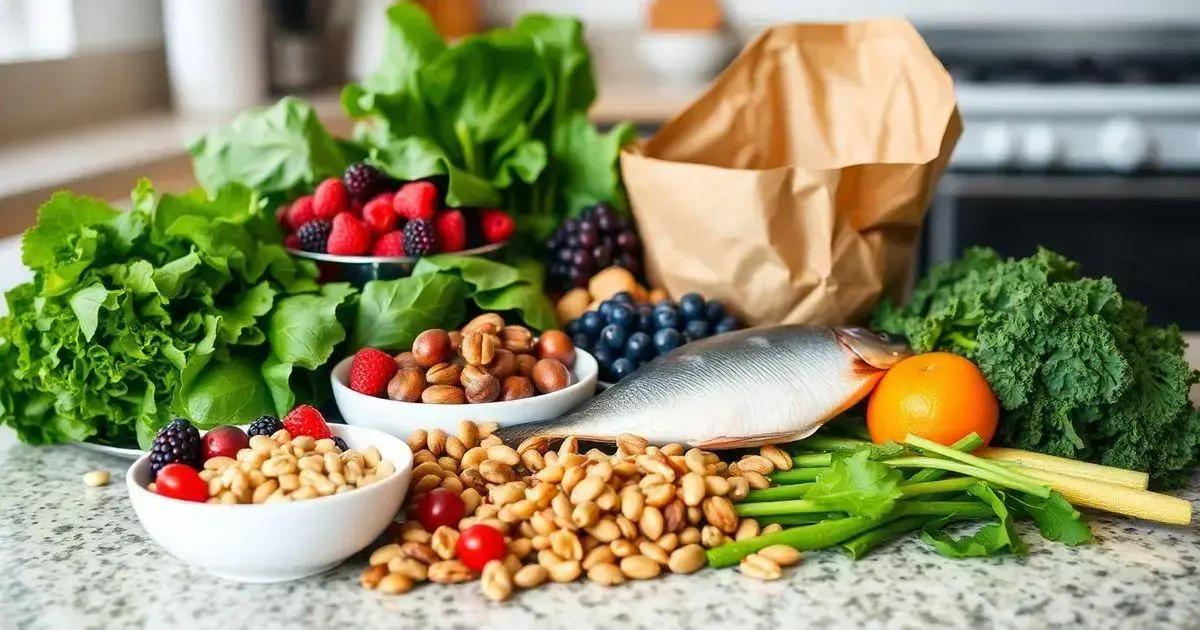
[[125, 425, 413, 582]]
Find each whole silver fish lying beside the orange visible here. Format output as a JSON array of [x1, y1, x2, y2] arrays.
[[499, 325, 912, 450]]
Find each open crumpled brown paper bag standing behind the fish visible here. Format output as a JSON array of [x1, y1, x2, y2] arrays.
[[620, 19, 962, 324]]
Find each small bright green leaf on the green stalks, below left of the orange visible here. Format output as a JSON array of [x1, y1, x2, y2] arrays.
[[804, 450, 901, 518]]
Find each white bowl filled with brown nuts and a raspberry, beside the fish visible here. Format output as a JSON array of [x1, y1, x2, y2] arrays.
[[330, 313, 599, 437]]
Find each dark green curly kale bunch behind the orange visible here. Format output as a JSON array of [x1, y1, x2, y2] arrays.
[[875, 248, 1200, 487]]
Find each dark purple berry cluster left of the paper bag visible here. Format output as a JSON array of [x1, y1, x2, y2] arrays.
[[546, 203, 642, 292]]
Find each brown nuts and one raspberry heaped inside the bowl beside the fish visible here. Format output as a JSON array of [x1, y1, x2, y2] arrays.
[[349, 313, 575, 404]]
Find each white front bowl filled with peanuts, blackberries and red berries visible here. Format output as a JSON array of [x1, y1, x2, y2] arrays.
[[125, 406, 413, 582]]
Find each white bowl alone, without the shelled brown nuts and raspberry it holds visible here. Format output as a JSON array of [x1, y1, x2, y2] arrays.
[[330, 349, 599, 438]]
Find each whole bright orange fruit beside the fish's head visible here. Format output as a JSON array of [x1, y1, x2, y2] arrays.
[[866, 352, 1000, 445]]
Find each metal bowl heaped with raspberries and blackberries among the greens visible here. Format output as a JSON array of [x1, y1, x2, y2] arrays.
[[276, 162, 516, 286]]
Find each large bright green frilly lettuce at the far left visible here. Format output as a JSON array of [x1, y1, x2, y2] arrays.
[[0, 180, 353, 446]]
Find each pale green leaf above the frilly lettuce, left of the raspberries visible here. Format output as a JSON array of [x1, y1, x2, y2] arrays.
[[188, 96, 349, 197]]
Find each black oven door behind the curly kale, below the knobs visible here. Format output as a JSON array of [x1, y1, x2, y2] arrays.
[[920, 173, 1200, 330]]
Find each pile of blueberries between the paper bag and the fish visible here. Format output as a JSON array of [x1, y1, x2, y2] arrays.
[[566, 292, 739, 383]]
